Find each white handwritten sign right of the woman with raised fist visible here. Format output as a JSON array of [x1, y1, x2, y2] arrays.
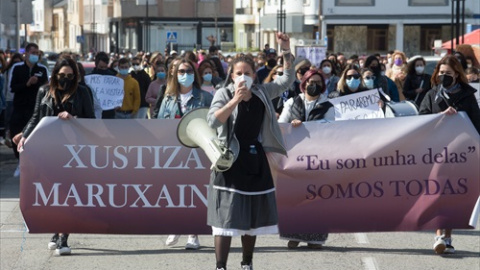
[[329, 89, 385, 121]]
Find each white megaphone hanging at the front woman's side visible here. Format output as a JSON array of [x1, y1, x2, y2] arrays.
[[177, 108, 233, 172]]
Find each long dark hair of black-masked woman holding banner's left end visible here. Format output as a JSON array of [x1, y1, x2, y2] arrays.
[[49, 58, 80, 104]]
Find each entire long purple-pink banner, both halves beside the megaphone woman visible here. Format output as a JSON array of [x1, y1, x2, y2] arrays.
[[20, 115, 480, 234]]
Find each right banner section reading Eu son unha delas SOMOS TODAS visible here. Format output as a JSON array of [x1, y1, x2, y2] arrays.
[[271, 113, 480, 233]]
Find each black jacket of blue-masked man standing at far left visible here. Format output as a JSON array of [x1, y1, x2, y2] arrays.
[[9, 61, 48, 111]]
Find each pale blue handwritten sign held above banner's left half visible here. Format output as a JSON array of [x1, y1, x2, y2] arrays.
[[85, 74, 124, 110]]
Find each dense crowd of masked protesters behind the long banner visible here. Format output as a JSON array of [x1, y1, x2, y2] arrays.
[[0, 36, 480, 269]]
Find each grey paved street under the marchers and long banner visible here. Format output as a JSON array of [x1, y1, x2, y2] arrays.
[[0, 146, 480, 270]]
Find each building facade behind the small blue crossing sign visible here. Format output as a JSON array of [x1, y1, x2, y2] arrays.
[[110, 0, 233, 52]]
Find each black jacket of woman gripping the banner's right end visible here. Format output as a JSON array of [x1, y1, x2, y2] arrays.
[[419, 84, 480, 133]]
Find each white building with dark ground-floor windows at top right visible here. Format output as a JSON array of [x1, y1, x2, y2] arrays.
[[321, 0, 480, 55]]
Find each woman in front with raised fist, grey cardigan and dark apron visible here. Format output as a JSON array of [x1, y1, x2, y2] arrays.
[[207, 33, 295, 270]]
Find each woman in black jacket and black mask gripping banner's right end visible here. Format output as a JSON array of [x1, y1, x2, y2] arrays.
[[419, 55, 480, 254]]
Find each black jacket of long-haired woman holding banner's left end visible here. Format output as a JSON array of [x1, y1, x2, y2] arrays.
[[23, 85, 95, 138]]
